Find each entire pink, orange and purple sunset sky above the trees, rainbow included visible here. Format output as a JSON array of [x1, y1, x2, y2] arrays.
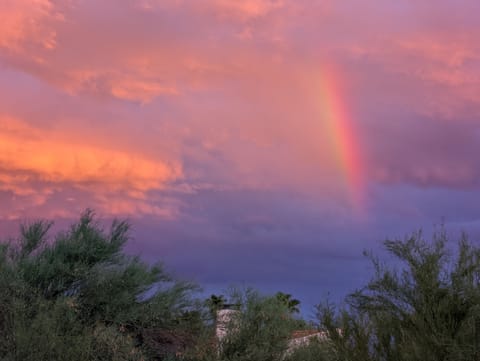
[[0, 0, 480, 316]]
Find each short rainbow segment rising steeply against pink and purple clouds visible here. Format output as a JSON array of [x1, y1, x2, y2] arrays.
[[319, 66, 364, 211]]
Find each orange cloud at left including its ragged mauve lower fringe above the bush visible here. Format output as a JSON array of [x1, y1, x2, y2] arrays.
[[0, 116, 183, 219]]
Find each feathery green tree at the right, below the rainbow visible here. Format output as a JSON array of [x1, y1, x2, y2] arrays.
[[319, 229, 480, 361]]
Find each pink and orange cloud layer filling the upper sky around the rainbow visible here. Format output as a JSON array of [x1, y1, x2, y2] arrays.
[[0, 0, 480, 219]]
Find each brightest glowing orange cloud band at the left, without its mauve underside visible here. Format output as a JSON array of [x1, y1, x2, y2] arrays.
[[0, 117, 182, 196]]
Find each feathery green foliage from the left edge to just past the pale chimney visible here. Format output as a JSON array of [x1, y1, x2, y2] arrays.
[[0, 210, 316, 361]]
